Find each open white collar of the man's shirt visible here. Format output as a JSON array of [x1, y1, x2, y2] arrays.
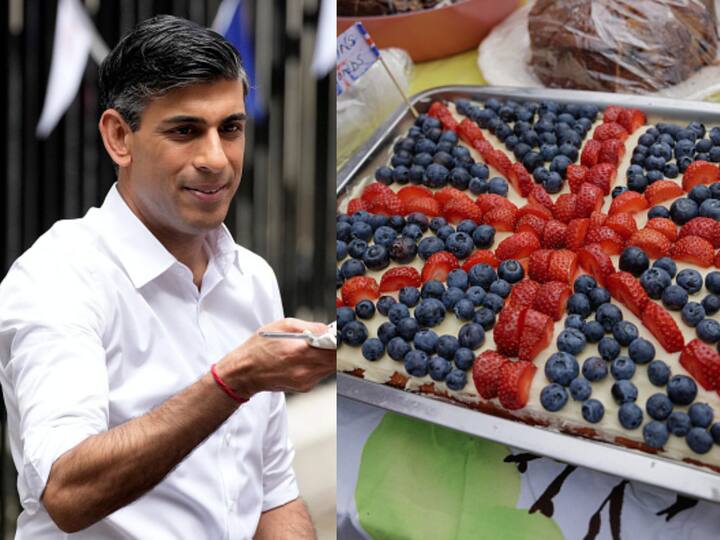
[[100, 183, 242, 289]]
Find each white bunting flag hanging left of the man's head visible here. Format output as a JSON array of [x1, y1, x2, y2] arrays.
[[35, 0, 108, 139]]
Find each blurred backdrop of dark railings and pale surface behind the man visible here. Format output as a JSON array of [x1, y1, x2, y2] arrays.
[[0, 0, 335, 538]]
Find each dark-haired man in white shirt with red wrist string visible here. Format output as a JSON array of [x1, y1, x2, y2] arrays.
[[0, 16, 335, 540]]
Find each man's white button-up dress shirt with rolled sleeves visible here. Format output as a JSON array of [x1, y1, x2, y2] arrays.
[[0, 186, 298, 540]]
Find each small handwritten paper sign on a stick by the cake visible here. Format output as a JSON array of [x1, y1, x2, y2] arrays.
[[335, 22, 380, 96]]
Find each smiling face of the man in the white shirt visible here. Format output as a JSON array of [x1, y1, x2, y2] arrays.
[[120, 81, 245, 236]]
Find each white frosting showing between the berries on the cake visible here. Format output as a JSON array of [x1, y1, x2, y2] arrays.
[[337, 100, 720, 466]]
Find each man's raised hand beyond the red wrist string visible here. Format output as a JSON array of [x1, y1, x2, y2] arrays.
[[216, 319, 336, 397]]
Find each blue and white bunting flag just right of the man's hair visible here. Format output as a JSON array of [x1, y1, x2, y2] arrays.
[[212, 0, 265, 121]]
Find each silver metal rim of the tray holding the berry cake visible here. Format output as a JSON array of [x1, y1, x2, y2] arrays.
[[337, 85, 720, 502]]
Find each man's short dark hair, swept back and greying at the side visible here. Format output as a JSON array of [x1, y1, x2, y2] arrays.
[[99, 15, 249, 131]]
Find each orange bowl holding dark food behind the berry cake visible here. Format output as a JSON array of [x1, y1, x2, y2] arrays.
[[337, 0, 521, 62]]
